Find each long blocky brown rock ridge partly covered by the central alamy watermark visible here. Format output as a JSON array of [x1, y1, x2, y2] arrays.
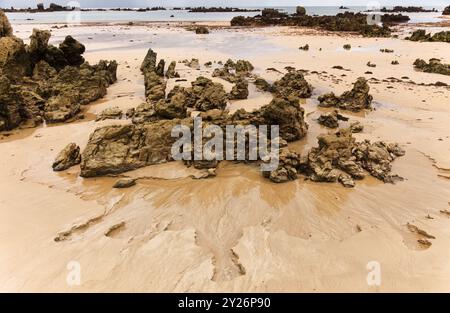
[[81, 92, 307, 177]]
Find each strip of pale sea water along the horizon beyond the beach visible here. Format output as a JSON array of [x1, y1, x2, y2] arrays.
[[7, 6, 443, 24]]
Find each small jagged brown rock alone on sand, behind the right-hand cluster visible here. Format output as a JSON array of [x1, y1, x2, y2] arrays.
[[319, 77, 373, 112]]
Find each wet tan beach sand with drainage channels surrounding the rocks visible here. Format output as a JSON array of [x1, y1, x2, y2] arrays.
[[0, 24, 450, 292]]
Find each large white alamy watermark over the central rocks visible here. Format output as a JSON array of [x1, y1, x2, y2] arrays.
[[171, 117, 280, 171]]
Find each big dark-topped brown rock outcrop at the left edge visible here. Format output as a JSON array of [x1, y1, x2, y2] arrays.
[[0, 15, 117, 131]]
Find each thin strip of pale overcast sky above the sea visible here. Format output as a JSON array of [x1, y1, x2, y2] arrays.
[[0, 0, 450, 8]]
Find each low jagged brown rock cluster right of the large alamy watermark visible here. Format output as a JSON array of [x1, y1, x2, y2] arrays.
[[265, 129, 405, 187]]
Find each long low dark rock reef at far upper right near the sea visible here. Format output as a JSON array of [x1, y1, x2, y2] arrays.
[[231, 9, 391, 37]]
